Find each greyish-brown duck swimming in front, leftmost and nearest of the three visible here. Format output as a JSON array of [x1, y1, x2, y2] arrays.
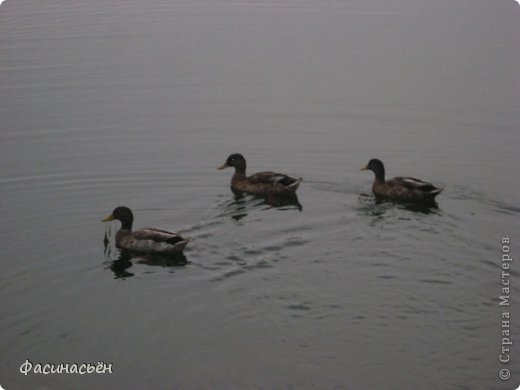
[[101, 206, 188, 255]]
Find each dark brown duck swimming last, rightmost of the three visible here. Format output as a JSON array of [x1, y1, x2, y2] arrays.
[[361, 158, 443, 202]]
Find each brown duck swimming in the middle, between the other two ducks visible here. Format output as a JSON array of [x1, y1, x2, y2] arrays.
[[218, 153, 302, 195]]
